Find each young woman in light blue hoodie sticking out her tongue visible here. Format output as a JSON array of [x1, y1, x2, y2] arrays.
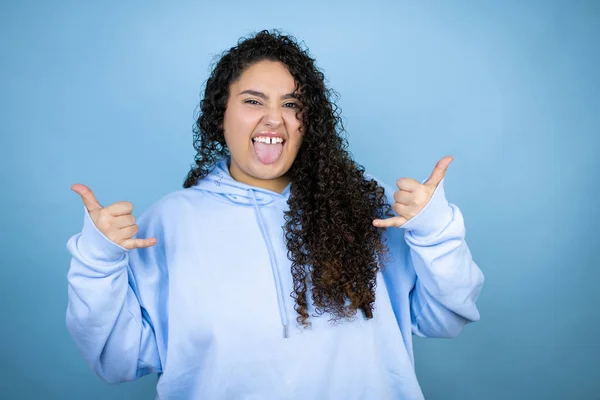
[[67, 31, 483, 400]]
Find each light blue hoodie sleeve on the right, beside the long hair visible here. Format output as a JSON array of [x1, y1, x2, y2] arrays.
[[382, 175, 484, 338]]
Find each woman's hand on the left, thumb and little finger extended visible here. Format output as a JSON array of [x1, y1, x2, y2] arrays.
[[71, 183, 156, 250]]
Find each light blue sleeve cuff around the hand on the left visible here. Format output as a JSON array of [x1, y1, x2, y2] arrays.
[[77, 207, 128, 263]]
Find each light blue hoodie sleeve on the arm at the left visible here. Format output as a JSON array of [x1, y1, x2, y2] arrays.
[[66, 202, 166, 383]]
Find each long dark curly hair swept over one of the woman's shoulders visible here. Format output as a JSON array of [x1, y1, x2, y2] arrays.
[[183, 30, 393, 327]]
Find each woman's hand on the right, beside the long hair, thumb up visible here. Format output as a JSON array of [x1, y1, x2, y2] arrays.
[[373, 156, 453, 228]]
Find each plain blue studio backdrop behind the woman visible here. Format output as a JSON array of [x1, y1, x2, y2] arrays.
[[0, 0, 600, 400]]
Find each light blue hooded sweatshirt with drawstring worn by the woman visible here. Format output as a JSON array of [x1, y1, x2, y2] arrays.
[[67, 159, 484, 400]]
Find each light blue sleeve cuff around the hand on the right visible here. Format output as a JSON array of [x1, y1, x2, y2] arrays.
[[402, 178, 453, 237]]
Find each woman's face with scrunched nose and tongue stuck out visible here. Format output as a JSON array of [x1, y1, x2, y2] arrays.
[[223, 61, 302, 193]]
